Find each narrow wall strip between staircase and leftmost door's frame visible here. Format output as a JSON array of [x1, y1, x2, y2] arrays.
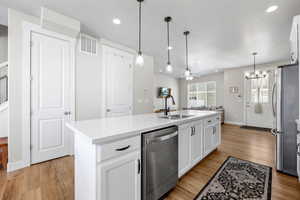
[[8, 9, 39, 163]]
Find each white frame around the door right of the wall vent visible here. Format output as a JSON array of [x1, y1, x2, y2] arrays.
[[100, 39, 135, 117]]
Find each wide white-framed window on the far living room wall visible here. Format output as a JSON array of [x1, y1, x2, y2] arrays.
[[188, 81, 216, 107]]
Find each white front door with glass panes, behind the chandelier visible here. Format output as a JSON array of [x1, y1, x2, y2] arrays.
[[244, 70, 275, 128]]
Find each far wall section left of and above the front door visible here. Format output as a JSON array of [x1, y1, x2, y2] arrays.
[[224, 61, 288, 124]]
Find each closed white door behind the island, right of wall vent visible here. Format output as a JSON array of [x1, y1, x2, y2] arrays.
[[104, 48, 133, 117]]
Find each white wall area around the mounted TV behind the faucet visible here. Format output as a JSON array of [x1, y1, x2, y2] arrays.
[[154, 73, 180, 110]]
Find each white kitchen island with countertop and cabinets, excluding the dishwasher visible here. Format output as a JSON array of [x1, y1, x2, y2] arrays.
[[67, 111, 221, 200]]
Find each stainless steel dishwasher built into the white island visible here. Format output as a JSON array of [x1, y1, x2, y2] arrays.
[[142, 126, 178, 200]]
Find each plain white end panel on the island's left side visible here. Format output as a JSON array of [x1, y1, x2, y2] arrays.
[[74, 134, 97, 200]]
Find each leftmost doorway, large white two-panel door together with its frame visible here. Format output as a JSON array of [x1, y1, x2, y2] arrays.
[[23, 24, 75, 165]]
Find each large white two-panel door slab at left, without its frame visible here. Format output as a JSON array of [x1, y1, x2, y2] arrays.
[[31, 32, 71, 163]]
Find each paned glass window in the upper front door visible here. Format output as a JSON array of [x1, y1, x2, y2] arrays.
[[251, 76, 269, 103]]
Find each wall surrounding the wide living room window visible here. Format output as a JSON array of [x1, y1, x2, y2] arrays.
[[180, 72, 224, 108]]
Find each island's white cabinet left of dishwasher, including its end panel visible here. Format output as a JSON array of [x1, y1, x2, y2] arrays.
[[75, 134, 141, 200]]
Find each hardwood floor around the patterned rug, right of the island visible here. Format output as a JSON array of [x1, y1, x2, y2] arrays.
[[166, 125, 300, 200]]
